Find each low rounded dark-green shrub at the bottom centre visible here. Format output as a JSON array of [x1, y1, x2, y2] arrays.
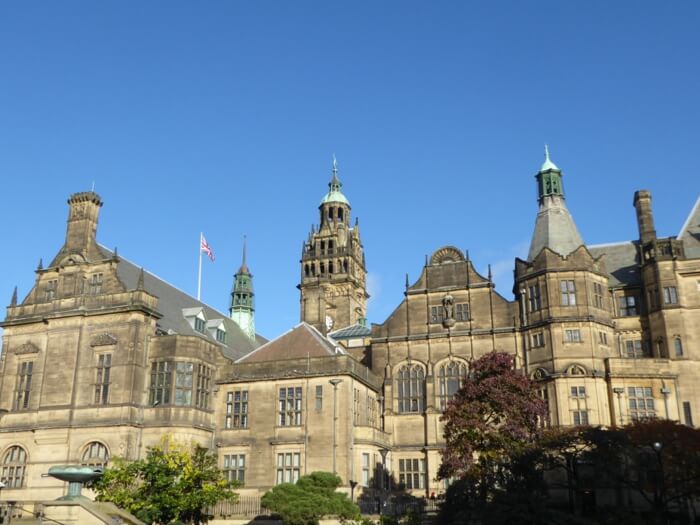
[[261, 472, 360, 525]]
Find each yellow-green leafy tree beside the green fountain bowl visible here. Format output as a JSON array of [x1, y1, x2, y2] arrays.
[[90, 441, 237, 525]]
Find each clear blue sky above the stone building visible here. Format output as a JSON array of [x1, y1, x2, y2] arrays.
[[0, 0, 700, 337]]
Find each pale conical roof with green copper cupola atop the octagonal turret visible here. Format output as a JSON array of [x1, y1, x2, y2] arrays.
[[527, 145, 583, 261]]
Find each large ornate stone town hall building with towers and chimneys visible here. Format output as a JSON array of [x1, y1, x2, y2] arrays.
[[0, 151, 700, 501]]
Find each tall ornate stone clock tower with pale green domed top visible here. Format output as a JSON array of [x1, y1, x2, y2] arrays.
[[297, 157, 369, 334]]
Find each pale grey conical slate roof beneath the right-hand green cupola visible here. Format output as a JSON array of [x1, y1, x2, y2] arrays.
[[527, 195, 583, 261]]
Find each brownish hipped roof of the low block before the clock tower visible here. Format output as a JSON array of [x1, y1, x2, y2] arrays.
[[236, 322, 345, 363]]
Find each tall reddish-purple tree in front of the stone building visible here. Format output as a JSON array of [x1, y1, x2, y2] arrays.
[[438, 352, 547, 519]]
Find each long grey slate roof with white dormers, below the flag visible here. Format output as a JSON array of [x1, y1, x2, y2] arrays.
[[100, 246, 267, 360]]
